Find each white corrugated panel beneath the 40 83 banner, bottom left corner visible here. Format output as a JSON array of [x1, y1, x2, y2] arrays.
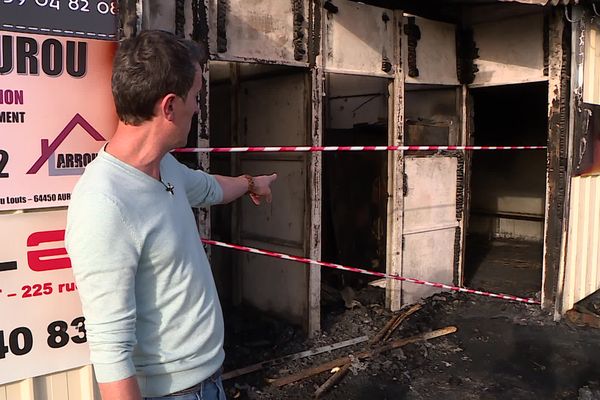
[[0, 365, 100, 400]]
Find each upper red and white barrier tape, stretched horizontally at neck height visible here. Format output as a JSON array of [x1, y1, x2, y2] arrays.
[[173, 146, 546, 153]]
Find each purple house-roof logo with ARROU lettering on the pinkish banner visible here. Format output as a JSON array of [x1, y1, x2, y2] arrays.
[[27, 114, 106, 176]]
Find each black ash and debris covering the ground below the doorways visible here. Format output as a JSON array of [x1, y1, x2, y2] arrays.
[[225, 287, 600, 400]]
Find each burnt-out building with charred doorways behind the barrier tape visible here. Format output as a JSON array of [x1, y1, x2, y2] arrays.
[[5, 0, 600, 399]]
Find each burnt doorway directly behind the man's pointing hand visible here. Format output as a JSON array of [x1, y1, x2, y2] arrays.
[[209, 61, 310, 326]]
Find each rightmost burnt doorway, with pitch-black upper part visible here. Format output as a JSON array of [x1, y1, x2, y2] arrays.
[[465, 82, 548, 297]]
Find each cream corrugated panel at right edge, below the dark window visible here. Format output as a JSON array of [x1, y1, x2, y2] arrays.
[[562, 176, 600, 312]]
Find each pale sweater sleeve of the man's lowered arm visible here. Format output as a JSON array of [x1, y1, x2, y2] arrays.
[[65, 193, 141, 382]]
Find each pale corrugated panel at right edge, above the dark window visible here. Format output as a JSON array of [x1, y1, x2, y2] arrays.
[[583, 24, 600, 104]]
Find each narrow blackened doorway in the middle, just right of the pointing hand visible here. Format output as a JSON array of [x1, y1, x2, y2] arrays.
[[321, 73, 390, 308]]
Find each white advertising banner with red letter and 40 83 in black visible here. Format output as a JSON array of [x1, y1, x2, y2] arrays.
[[0, 210, 89, 385]]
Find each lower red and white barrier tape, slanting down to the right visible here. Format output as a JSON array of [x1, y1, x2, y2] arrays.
[[202, 239, 541, 304]]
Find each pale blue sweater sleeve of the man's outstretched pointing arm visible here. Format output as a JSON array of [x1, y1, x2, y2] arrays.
[[169, 155, 223, 207]]
